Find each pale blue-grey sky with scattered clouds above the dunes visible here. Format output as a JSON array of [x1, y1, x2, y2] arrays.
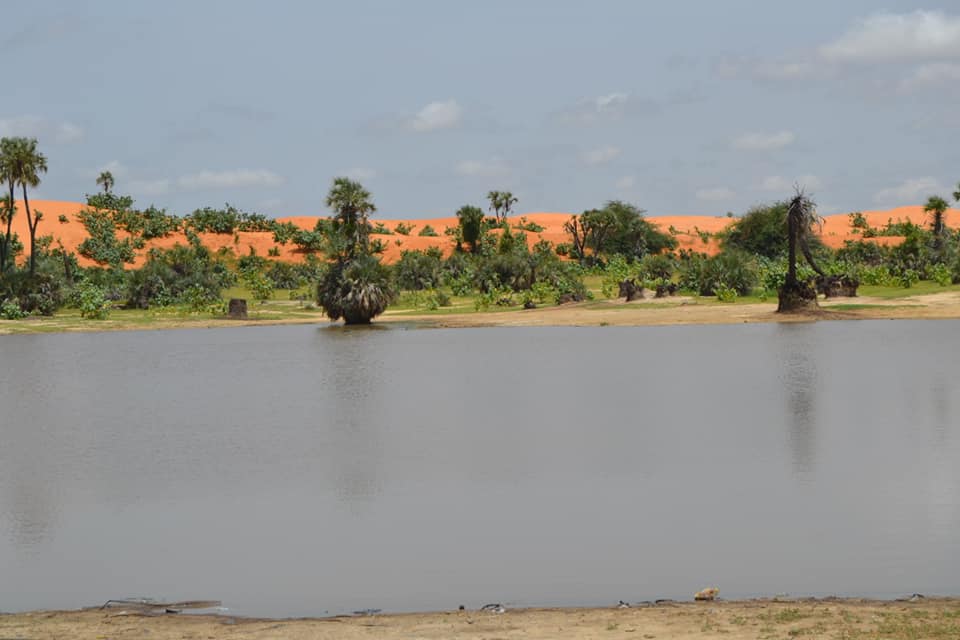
[[0, 0, 960, 219]]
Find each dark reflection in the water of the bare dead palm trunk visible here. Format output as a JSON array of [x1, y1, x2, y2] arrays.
[[776, 324, 817, 475]]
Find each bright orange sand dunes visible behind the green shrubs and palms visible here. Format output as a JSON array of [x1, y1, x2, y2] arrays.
[[7, 200, 960, 266]]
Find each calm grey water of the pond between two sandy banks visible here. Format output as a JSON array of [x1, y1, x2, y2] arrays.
[[0, 321, 960, 616]]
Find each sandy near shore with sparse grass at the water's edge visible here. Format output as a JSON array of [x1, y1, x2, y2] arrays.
[[0, 598, 960, 640]]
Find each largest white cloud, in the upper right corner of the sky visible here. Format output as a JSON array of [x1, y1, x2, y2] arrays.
[[820, 11, 960, 62]]
